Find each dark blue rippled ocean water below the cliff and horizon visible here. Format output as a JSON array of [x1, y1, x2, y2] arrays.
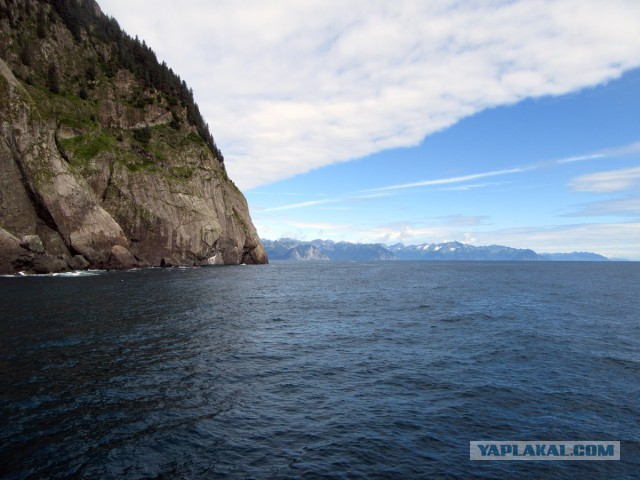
[[0, 262, 640, 480]]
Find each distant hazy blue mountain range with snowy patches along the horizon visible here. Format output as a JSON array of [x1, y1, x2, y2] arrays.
[[262, 238, 608, 262]]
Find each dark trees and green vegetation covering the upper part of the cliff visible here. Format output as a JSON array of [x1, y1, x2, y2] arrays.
[[0, 0, 224, 164]]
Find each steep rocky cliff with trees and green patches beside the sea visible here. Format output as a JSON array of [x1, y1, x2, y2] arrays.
[[0, 0, 267, 274]]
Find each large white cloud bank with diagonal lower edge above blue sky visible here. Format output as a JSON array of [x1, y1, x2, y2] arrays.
[[100, 0, 640, 189]]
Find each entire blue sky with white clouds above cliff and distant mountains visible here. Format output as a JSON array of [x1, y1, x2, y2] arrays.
[[98, 0, 640, 260]]
